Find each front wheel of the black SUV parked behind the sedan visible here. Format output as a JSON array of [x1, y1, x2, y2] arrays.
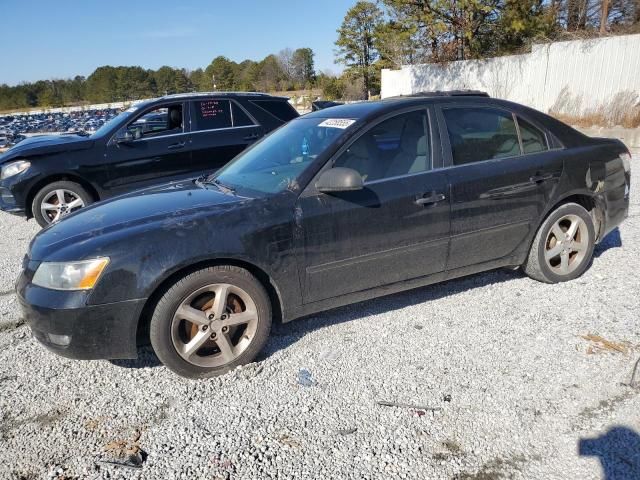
[[31, 181, 93, 227]]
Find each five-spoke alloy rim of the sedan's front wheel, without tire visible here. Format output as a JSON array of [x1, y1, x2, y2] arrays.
[[171, 283, 258, 367]]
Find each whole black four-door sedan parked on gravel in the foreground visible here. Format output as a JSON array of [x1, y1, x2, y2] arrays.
[[17, 92, 630, 378]]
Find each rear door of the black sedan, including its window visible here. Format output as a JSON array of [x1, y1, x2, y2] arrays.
[[439, 101, 545, 270]]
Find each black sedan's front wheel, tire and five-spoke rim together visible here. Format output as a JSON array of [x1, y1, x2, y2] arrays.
[[150, 266, 271, 378]]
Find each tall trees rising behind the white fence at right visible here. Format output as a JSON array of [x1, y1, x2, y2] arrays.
[[336, 0, 640, 98]]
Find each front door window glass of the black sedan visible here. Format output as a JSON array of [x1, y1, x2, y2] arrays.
[[334, 110, 431, 182]]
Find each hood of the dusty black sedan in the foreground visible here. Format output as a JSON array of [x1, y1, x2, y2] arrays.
[[29, 180, 252, 261]]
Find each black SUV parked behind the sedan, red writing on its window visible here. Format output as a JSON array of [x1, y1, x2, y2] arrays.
[[0, 92, 298, 226]]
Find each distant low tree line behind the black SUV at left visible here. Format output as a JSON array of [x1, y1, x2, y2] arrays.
[[0, 48, 318, 110]]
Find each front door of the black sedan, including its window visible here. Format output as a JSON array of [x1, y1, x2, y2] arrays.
[[297, 109, 449, 303]]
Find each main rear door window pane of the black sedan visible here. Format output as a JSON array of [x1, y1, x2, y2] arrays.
[[443, 107, 520, 165]]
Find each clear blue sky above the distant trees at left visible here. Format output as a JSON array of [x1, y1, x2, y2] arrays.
[[0, 0, 355, 85]]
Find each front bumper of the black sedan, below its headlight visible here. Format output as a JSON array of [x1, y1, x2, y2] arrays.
[[17, 273, 145, 360]]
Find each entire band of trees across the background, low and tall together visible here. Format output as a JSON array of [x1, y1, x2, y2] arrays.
[[0, 0, 640, 110]]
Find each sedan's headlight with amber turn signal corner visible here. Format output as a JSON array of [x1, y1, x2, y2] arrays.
[[32, 258, 109, 290]]
